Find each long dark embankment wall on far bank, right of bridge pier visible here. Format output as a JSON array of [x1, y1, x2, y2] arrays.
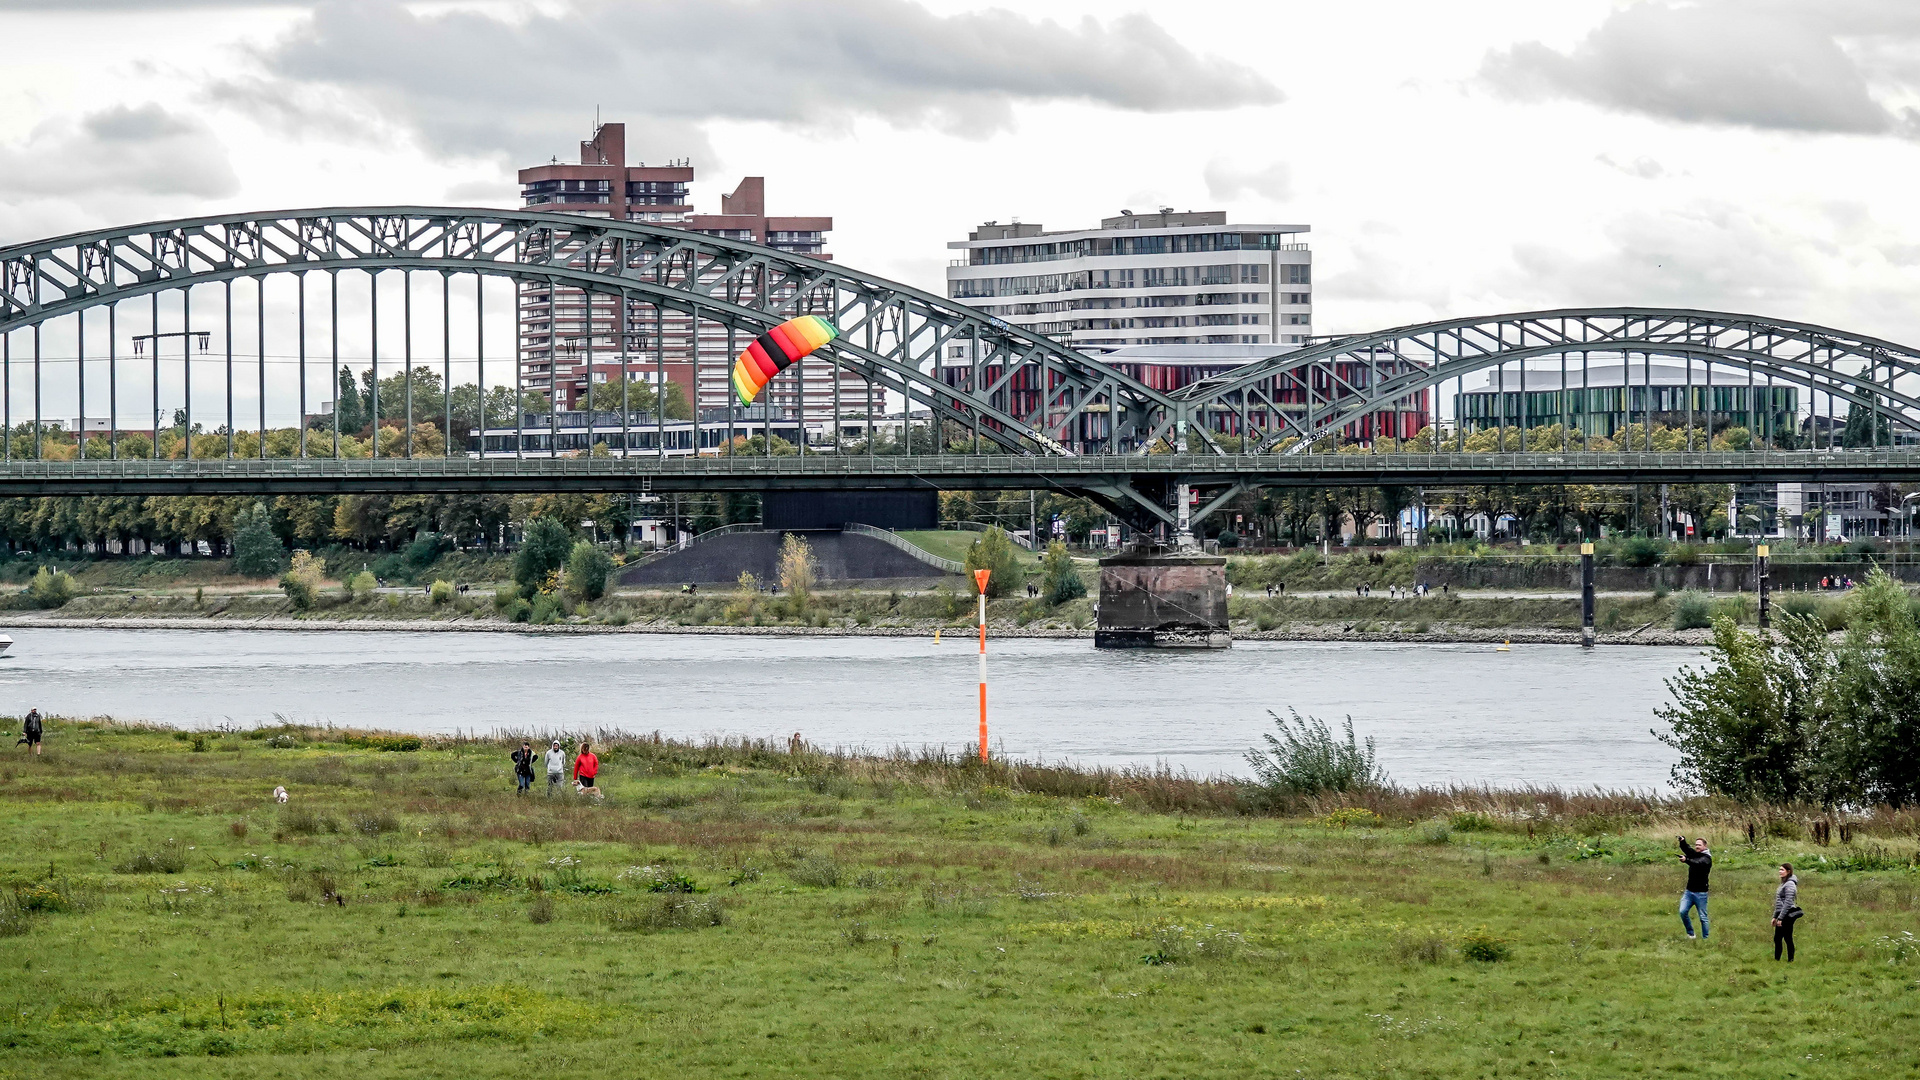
[[1415, 559, 1920, 592]]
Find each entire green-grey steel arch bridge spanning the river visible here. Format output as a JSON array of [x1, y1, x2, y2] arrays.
[[0, 206, 1920, 523]]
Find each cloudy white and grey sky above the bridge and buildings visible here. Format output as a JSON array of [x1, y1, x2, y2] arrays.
[[0, 0, 1920, 342]]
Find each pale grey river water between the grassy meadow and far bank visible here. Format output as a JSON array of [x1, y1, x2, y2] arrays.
[[0, 628, 1701, 790]]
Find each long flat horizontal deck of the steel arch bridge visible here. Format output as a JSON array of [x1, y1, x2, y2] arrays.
[[0, 450, 1920, 496]]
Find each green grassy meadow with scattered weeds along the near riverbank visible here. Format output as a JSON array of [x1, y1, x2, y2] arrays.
[[0, 723, 1920, 1080]]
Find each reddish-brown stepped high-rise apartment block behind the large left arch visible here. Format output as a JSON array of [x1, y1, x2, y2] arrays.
[[518, 123, 844, 419]]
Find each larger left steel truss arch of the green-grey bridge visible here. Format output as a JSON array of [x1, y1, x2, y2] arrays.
[[0, 206, 1169, 454]]
